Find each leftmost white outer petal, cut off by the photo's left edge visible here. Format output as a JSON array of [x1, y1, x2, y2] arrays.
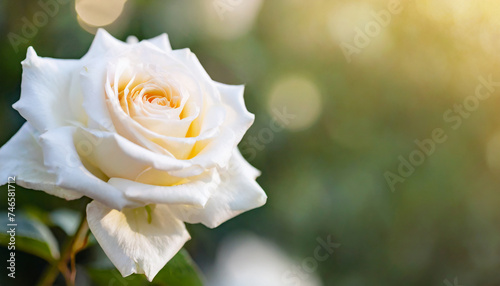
[[0, 123, 82, 200]]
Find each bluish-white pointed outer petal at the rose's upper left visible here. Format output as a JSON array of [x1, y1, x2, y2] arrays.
[[13, 47, 81, 132]]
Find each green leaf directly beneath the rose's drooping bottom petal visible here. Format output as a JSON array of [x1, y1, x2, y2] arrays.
[[87, 249, 203, 286]]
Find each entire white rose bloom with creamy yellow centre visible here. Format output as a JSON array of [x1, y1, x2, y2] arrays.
[[0, 29, 267, 281]]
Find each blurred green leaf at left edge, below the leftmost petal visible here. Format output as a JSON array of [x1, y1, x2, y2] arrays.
[[0, 212, 60, 262]]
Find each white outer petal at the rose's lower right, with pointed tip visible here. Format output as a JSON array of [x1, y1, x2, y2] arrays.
[[171, 150, 267, 228]]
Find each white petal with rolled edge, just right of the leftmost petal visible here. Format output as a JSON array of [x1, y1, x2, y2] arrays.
[[40, 127, 137, 209]]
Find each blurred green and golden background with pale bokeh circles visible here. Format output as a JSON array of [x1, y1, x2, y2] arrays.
[[0, 0, 500, 286]]
